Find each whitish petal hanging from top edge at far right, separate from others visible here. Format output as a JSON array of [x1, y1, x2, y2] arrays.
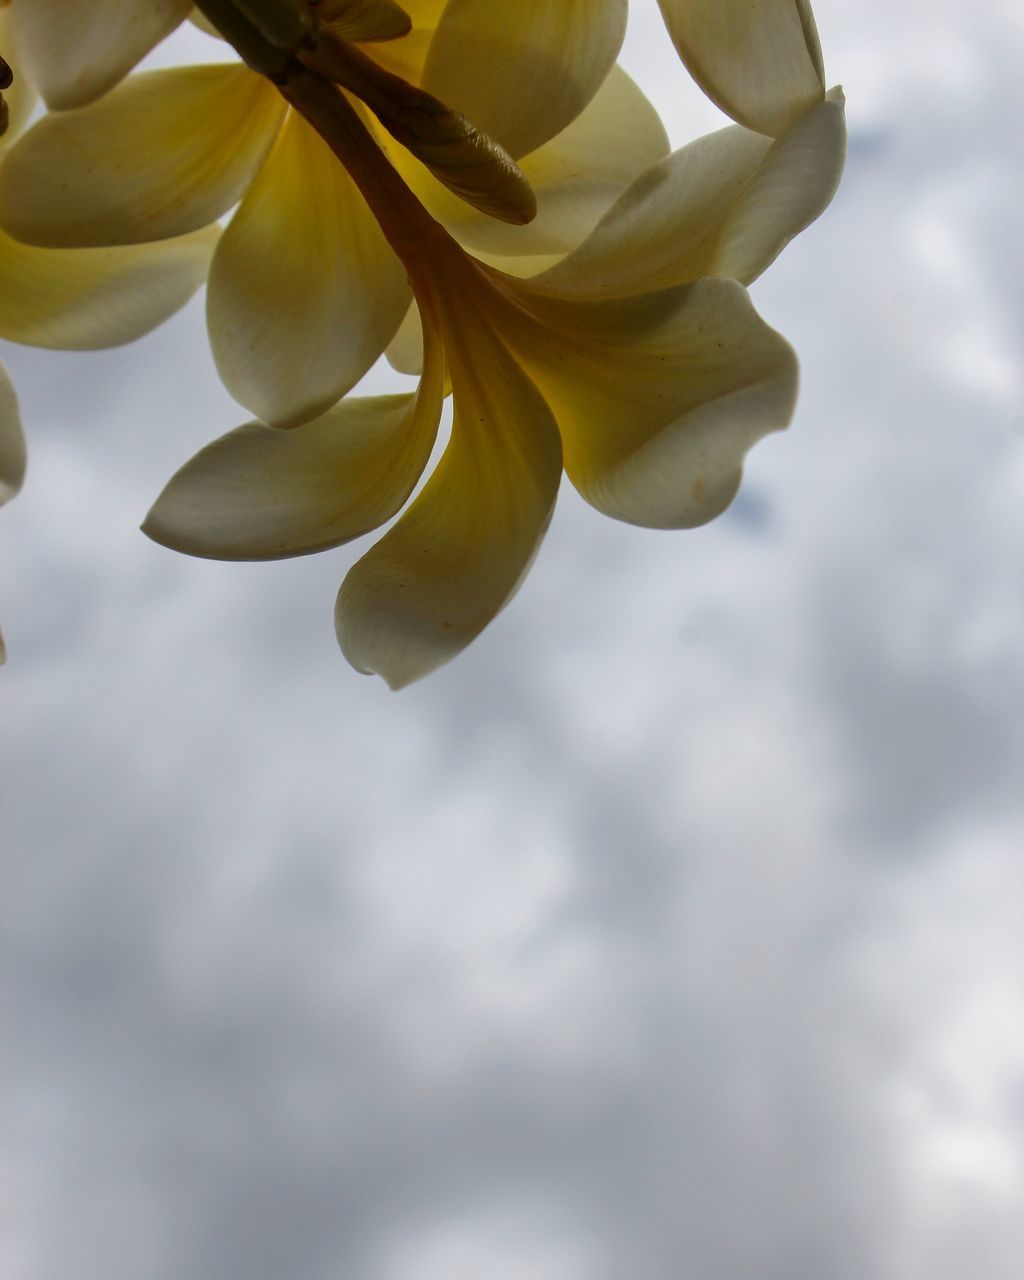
[[658, 0, 824, 137]]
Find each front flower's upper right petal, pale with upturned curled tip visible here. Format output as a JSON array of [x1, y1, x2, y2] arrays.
[[544, 91, 846, 296]]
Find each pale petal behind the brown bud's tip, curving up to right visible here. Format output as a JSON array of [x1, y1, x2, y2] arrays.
[[393, 65, 668, 257]]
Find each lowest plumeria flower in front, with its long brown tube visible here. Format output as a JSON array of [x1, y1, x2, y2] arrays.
[[133, 6, 845, 687]]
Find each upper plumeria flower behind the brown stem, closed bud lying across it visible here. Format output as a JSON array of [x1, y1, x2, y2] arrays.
[[0, 0, 668, 426]]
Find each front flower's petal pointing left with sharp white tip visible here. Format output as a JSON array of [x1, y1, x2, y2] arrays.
[[142, 312, 444, 559]]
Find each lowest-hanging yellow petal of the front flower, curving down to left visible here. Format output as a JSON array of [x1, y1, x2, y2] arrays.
[[335, 304, 562, 689]]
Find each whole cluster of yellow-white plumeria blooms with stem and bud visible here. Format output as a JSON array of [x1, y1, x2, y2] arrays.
[[0, 0, 845, 687]]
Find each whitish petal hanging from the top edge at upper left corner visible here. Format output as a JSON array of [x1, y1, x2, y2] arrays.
[[12, 0, 192, 111]]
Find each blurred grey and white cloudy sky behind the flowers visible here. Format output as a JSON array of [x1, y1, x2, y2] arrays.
[[0, 0, 1024, 1280]]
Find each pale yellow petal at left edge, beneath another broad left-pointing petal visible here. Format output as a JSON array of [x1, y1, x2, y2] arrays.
[[0, 228, 218, 351]]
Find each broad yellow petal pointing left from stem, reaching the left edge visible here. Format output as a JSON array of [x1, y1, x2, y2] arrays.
[[0, 64, 284, 247]]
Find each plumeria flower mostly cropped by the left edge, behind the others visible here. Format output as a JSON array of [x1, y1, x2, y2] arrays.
[[0, 6, 216, 658]]
